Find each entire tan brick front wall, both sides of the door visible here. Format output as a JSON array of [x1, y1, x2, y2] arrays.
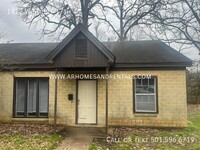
[[0, 70, 187, 127]]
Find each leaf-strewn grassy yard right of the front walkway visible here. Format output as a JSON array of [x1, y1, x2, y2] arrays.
[[90, 105, 200, 150]]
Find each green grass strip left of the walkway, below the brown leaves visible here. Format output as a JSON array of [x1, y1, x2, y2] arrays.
[[0, 134, 62, 150]]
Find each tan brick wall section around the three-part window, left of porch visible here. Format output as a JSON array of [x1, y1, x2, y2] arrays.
[[0, 71, 55, 121]]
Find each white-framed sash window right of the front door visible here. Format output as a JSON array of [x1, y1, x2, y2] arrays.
[[134, 77, 158, 113]]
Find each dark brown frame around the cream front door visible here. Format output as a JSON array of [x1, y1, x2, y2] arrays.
[[75, 79, 98, 125]]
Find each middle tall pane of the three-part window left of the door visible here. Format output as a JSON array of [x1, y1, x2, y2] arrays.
[[27, 79, 37, 116]]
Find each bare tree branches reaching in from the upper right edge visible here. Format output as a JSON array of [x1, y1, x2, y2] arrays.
[[145, 0, 200, 52]]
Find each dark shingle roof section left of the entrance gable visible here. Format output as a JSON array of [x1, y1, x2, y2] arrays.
[[0, 43, 58, 64]]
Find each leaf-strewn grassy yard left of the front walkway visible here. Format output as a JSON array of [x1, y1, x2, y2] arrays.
[[0, 123, 62, 150]]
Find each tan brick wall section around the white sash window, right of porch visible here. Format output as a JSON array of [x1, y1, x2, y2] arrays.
[[109, 71, 187, 127]]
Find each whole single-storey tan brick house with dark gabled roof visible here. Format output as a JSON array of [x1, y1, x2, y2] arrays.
[[0, 24, 192, 127]]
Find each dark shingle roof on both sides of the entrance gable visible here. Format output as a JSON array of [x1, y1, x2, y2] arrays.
[[0, 41, 191, 66]]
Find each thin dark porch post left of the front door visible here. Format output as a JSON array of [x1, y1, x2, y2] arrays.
[[54, 68, 58, 133]]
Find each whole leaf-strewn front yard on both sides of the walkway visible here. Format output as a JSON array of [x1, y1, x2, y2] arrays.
[[0, 105, 200, 150]]
